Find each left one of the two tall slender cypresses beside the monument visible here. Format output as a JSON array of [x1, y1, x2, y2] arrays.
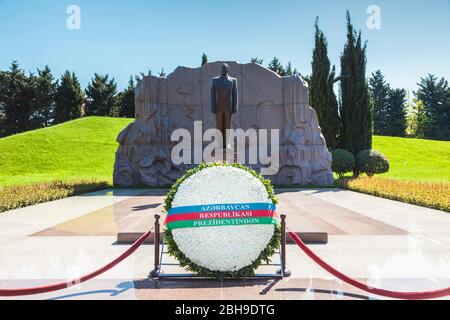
[[308, 19, 341, 150]]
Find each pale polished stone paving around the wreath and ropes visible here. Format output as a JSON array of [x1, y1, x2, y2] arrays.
[[0, 189, 450, 299]]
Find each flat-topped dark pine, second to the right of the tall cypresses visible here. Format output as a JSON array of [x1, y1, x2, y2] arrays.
[[385, 89, 406, 137]]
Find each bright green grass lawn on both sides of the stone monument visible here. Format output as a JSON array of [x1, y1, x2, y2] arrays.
[[0, 117, 450, 186]]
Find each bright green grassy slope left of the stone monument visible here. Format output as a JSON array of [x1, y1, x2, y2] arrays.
[[0, 117, 132, 186]]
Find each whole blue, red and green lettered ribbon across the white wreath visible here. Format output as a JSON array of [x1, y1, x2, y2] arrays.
[[165, 203, 278, 230]]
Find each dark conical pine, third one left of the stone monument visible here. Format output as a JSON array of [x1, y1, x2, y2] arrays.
[[54, 71, 84, 123]]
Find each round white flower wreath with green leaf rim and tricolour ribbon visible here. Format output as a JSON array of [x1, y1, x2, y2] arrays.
[[165, 163, 281, 278]]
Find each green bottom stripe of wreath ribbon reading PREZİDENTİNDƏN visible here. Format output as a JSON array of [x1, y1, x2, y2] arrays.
[[167, 217, 278, 230]]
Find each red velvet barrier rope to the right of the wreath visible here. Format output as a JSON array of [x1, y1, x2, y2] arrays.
[[289, 232, 450, 300]]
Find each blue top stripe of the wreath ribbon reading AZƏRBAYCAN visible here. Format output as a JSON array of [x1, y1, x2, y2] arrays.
[[169, 203, 276, 215]]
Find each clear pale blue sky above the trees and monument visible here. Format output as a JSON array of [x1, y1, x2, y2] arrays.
[[0, 0, 450, 90]]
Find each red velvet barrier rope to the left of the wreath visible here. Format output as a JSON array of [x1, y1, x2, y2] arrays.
[[0, 231, 151, 297]]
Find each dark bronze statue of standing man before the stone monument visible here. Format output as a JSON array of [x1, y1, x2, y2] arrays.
[[211, 63, 239, 149]]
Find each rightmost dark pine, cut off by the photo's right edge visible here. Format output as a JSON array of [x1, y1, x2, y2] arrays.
[[415, 74, 450, 140]]
